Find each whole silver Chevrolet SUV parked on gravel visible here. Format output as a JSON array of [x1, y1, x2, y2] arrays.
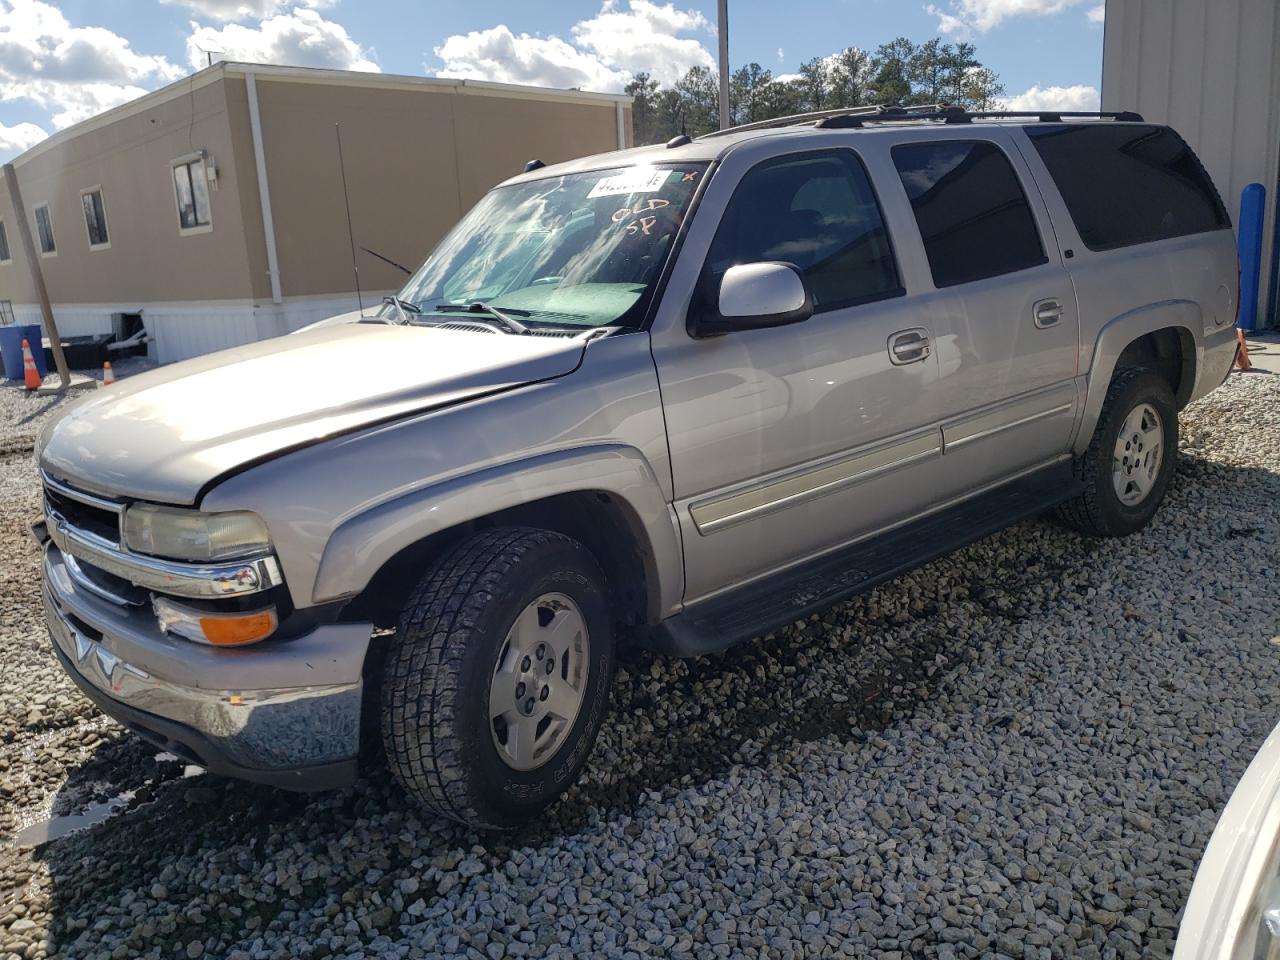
[[35, 103, 1238, 828]]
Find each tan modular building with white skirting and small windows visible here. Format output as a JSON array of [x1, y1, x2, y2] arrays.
[[0, 63, 631, 362]]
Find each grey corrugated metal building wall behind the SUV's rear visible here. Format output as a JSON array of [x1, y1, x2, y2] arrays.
[[1102, 0, 1280, 326]]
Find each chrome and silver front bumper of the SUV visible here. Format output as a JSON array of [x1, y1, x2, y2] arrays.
[[42, 543, 371, 790]]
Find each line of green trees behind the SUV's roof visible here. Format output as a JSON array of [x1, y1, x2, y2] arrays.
[[625, 37, 1005, 145]]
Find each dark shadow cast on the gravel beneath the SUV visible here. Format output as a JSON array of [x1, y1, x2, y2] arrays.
[[24, 457, 1280, 956]]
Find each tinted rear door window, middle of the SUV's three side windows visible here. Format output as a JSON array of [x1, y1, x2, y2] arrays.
[[893, 140, 1046, 287]]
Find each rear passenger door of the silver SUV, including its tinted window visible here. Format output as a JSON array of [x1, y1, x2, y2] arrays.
[[890, 127, 1080, 498]]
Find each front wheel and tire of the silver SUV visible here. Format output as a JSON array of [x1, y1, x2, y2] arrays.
[[381, 527, 613, 829]]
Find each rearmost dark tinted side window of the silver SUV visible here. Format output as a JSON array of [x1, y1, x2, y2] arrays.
[[1027, 124, 1230, 250]]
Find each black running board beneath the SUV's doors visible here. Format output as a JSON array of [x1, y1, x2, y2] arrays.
[[641, 461, 1082, 657]]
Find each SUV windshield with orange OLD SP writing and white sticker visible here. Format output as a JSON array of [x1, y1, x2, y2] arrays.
[[399, 163, 707, 326]]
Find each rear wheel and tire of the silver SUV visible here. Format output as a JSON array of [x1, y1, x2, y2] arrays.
[[1057, 367, 1178, 536]]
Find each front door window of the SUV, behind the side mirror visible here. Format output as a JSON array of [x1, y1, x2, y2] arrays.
[[707, 150, 902, 310]]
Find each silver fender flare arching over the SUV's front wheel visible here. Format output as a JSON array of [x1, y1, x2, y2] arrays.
[[312, 444, 685, 620]]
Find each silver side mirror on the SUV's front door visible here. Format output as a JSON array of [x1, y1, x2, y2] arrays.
[[690, 261, 813, 337]]
